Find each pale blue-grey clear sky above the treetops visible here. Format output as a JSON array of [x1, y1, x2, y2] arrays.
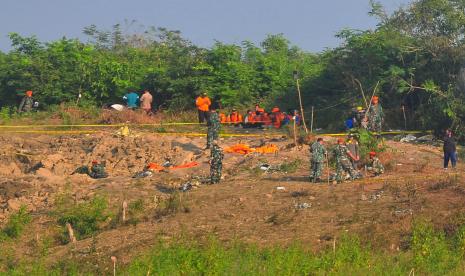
[[0, 0, 411, 51]]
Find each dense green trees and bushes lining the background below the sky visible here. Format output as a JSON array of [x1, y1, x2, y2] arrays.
[[0, 0, 465, 133]]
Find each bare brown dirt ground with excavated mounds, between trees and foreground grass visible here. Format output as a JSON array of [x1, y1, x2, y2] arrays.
[[0, 130, 465, 268]]
